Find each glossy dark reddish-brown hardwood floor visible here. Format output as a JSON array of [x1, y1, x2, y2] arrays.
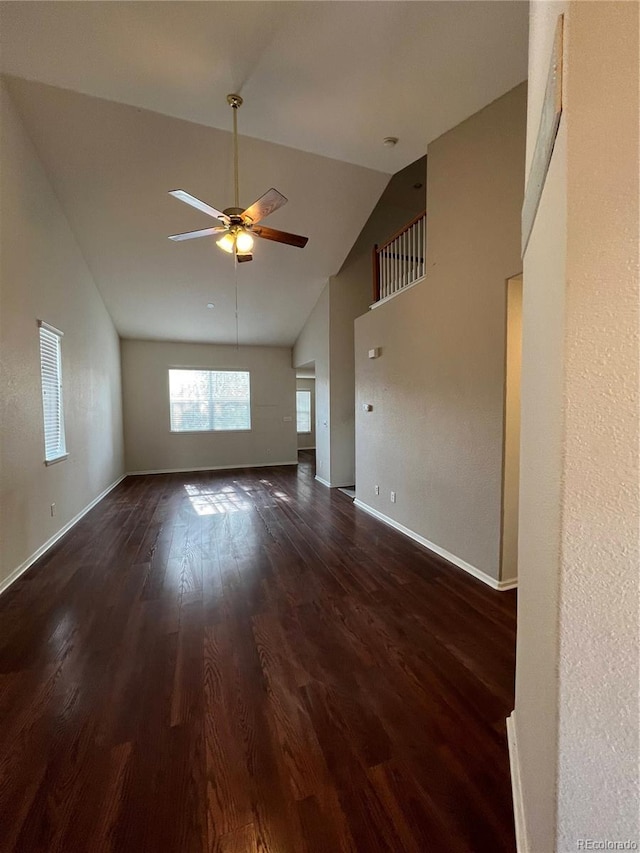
[[0, 454, 515, 853]]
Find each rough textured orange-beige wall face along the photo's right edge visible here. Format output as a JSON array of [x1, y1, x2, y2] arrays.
[[557, 2, 640, 851]]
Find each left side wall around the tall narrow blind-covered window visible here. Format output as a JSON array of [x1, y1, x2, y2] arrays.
[[0, 84, 124, 584]]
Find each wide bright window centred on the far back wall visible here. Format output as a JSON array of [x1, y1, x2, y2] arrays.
[[169, 369, 251, 432]]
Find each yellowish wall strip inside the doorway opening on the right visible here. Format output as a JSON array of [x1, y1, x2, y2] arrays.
[[500, 275, 522, 581]]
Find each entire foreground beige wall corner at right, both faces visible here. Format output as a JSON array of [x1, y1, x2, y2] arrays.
[[515, 3, 640, 853]]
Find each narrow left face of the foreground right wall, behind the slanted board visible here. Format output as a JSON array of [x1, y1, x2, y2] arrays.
[[515, 3, 567, 853]]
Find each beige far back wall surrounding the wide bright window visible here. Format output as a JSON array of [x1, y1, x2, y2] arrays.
[[122, 340, 297, 472]]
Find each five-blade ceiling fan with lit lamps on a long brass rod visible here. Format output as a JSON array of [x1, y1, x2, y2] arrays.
[[169, 95, 309, 262]]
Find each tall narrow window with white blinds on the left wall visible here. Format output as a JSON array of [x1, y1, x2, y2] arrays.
[[39, 320, 67, 464]]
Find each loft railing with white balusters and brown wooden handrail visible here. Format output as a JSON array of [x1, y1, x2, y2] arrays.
[[373, 212, 427, 302]]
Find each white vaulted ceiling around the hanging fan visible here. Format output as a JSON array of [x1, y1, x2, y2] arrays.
[[0, 0, 528, 344]]
